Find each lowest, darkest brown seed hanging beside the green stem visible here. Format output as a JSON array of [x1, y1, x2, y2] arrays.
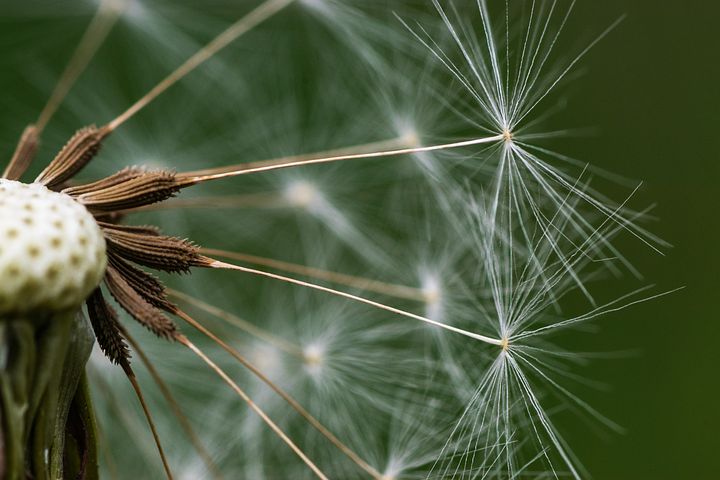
[[86, 287, 130, 366]]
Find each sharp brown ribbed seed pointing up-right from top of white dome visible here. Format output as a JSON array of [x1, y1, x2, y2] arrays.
[[35, 125, 110, 190]]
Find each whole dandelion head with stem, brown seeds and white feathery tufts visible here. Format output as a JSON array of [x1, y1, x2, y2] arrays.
[[0, 0, 676, 480]]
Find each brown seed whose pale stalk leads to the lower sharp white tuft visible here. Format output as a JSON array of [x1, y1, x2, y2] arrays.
[[101, 224, 205, 273]]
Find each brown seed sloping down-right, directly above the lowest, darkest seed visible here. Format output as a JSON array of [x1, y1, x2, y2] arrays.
[[105, 266, 177, 339]]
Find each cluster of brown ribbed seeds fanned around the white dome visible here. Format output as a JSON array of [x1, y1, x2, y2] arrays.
[[0, 126, 212, 367]]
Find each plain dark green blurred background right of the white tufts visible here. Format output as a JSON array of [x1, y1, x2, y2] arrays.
[[572, 1, 720, 478]]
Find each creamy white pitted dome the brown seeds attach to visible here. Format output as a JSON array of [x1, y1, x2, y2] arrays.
[[0, 179, 107, 316]]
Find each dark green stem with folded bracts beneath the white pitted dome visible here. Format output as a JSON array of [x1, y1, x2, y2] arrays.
[[0, 312, 97, 480]]
